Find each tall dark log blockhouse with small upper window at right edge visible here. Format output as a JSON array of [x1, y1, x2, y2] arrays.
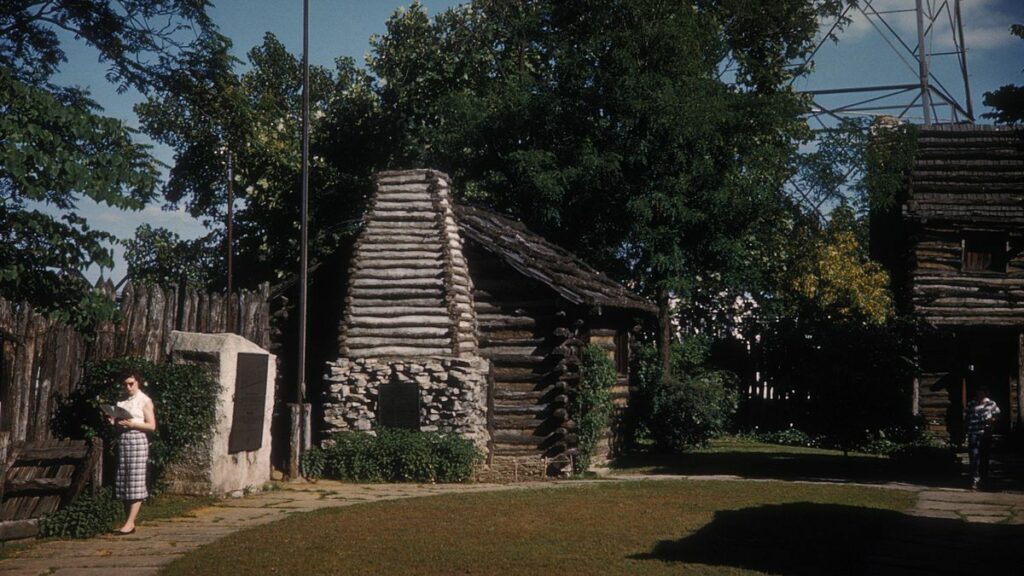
[[872, 124, 1024, 441]]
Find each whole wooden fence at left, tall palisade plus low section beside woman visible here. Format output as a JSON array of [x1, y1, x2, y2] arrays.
[[0, 282, 270, 541]]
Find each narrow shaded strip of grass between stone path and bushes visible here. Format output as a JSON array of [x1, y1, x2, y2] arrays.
[[612, 437, 962, 486]]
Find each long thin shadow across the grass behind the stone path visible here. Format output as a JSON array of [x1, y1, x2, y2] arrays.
[[612, 449, 965, 487]]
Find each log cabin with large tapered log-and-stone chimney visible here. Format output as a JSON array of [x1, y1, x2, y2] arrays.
[[323, 170, 656, 479]]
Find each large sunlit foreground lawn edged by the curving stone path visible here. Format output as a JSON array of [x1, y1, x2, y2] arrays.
[[165, 480, 915, 576]]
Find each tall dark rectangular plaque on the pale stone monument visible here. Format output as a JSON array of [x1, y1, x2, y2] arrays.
[[227, 353, 270, 454]]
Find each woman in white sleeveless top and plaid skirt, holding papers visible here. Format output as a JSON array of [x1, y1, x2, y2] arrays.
[[114, 371, 157, 535]]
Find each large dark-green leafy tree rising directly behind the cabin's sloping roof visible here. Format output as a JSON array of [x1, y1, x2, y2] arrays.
[[369, 0, 839, 368]]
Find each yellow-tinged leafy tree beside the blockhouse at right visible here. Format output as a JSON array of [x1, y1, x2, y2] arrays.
[[749, 123, 914, 450]]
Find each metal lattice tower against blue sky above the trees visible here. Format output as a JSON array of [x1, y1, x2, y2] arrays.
[[786, 0, 974, 221]]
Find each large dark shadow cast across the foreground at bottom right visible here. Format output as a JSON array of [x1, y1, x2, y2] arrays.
[[631, 502, 1024, 576]]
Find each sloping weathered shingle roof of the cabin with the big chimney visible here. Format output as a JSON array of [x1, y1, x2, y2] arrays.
[[455, 205, 657, 314]]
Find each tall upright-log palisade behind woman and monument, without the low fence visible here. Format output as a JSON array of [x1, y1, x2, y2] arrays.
[[0, 284, 270, 443]]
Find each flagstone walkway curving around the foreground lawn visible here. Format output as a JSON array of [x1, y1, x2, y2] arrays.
[[0, 476, 1024, 576]]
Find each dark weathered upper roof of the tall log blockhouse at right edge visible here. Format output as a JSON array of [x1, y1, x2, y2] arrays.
[[905, 124, 1024, 224]]
